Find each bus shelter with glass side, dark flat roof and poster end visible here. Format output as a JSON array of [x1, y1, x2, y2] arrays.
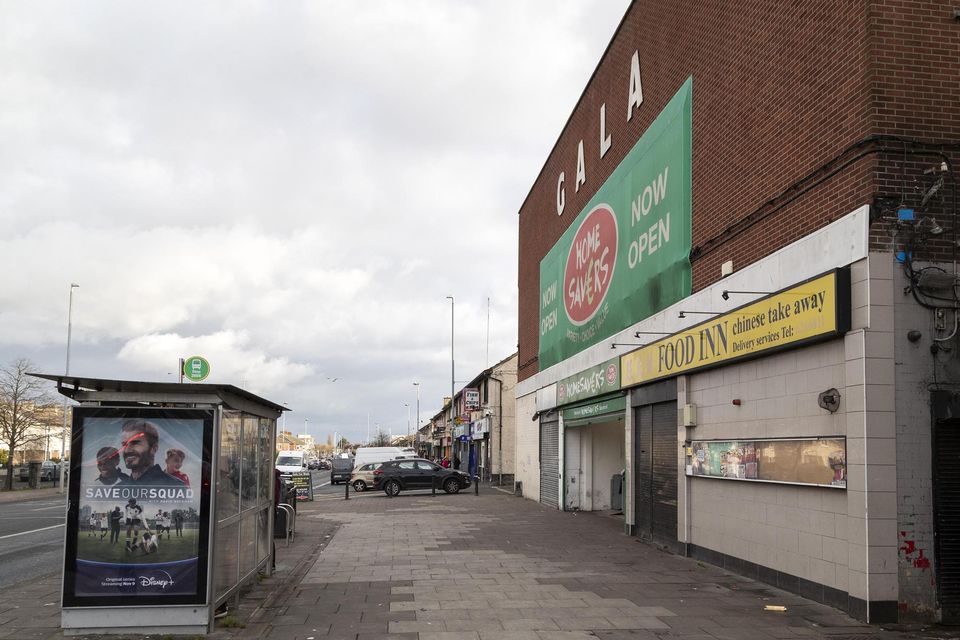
[[36, 374, 286, 635]]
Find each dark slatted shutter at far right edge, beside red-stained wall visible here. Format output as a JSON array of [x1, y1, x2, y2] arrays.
[[933, 420, 960, 624]]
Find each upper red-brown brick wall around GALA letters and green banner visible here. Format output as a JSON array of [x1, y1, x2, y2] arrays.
[[518, 0, 960, 380]]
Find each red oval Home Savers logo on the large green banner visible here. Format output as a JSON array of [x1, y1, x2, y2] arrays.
[[563, 204, 617, 325]]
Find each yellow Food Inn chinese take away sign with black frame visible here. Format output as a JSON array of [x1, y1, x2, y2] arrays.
[[620, 269, 850, 387]]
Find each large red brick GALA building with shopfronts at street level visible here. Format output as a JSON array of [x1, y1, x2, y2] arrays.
[[517, 1, 960, 622]]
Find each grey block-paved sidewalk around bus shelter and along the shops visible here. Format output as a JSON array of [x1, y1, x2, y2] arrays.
[[0, 485, 957, 640]]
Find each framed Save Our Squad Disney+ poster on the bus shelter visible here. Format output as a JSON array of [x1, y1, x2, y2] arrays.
[[64, 407, 213, 605]]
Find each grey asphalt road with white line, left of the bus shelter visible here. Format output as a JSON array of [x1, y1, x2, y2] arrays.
[[0, 496, 66, 588]]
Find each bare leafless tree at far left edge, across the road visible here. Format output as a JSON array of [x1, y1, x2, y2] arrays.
[[0, 358, 57, 490]]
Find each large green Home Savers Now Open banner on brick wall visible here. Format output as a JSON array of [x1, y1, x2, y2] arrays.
[[539, 78, 693, 369]]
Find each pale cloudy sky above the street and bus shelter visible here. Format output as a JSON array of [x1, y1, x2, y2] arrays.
[[0, 0, 628, 442]]
